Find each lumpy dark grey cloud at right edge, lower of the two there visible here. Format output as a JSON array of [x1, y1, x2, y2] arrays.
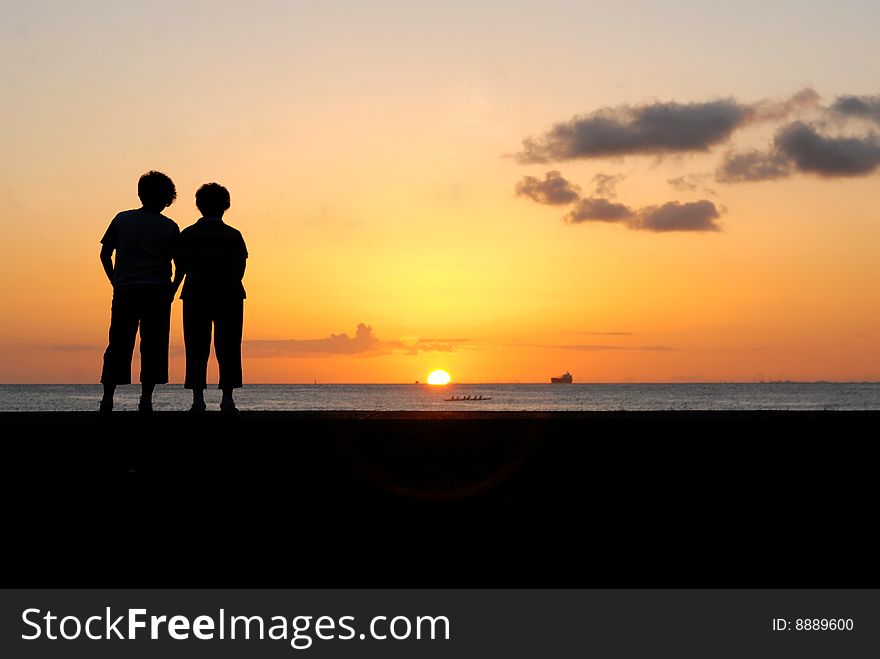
[[715, 121, 880, 183]]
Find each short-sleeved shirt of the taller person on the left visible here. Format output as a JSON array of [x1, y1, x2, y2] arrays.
[[101, 210, 180, 289]]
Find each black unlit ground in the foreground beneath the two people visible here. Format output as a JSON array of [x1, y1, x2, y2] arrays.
[[8, 412, 880, 587]]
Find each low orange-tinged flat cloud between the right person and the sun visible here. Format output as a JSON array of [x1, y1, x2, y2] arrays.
[[245, 323, 467, 357]]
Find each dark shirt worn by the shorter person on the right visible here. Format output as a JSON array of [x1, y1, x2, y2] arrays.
[[177, 217, 247, 300]]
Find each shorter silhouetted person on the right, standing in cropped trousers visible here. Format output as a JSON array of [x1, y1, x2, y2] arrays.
[[175, 183, 248, 412]]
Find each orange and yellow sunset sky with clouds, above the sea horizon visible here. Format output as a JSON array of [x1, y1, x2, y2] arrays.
[[0, 0, 880, 383]]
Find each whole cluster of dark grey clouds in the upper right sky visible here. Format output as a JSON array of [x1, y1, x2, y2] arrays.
[[515, 88, 880, 232]]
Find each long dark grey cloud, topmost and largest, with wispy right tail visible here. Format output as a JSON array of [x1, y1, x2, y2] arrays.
[[516, 89, 819, 163]]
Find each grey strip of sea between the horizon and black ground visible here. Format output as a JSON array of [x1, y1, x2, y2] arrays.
[[0, 382, 880, 412]]
